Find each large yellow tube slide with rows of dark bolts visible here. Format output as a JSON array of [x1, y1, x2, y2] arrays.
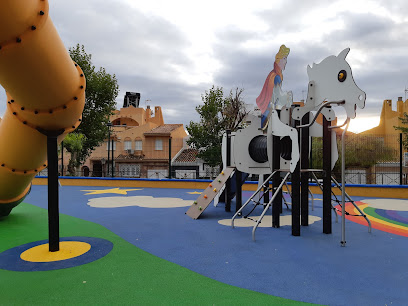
[[0, 0, 85, 217]]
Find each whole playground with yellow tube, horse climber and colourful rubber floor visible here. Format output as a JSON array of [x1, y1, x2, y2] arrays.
[[0, 0, 408, 305]]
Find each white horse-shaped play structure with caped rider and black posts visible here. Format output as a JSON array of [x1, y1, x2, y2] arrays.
[[187, 45, 371, 246]]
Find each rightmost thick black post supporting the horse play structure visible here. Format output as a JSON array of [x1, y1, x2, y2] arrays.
[[323, 116, 332, 234]]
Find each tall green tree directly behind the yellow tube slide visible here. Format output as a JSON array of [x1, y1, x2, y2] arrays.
[[69, 44, 119, 163]]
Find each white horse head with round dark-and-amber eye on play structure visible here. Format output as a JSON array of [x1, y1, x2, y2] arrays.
[[293, 48, 366, 120]]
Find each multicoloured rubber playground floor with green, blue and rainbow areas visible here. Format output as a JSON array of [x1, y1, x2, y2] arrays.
[[0, 180, 408, 305]]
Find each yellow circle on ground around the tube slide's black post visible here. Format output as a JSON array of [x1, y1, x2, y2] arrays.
[[20, 241, 91, 262]]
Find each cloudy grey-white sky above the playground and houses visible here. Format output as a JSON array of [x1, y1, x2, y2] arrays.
[[0, 0, 408, 132]]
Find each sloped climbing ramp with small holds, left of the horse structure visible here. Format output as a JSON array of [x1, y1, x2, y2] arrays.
[[186, 167, 235, 219]]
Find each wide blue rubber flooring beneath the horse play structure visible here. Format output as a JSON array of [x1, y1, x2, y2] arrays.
[[25, 186, 408, 305]]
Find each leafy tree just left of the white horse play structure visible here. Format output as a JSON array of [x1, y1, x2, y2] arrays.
[[186, 86, 247, 167]]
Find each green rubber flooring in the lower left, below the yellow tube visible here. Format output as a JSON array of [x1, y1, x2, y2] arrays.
[[0, 203, 305, 305]]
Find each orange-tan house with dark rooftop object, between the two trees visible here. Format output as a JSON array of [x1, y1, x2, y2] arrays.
[[60, 92, 187, 178]]
